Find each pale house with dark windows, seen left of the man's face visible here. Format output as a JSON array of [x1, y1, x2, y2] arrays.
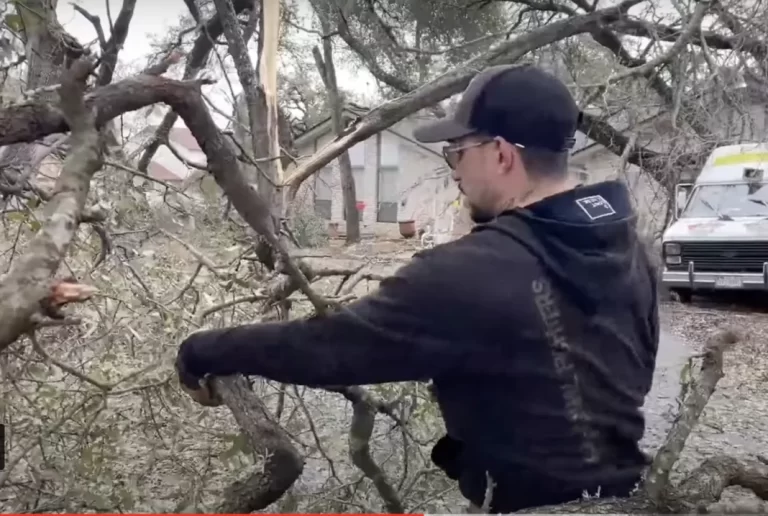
[[286, 104, 459, 239]]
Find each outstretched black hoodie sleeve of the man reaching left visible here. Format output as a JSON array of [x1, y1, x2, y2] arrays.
[[180, 249, 464, 386]]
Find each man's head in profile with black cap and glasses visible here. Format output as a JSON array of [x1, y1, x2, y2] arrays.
[[414, 65, 580, 222]]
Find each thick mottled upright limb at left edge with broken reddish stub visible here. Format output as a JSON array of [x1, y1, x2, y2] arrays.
[[0, 59, 102, 351]]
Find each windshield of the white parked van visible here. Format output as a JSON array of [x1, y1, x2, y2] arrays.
[[681, 183, 768, 220]]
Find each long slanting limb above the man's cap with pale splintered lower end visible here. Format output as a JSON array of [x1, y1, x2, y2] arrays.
[[286, 0, 643, 200]]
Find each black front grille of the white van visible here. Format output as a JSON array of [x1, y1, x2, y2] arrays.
[[674, 242, 768, 273]]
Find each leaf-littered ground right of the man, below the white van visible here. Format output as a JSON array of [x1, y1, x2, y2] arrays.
[[645, 300, 768, 504]]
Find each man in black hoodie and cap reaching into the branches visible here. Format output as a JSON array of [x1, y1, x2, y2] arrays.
[[178, 66, 658, 512]]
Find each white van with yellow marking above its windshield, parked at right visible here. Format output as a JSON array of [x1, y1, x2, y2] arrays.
[[662, 143, 768, 302]]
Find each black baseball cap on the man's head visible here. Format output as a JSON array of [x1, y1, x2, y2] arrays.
[[413, 64, 581, 151]]
